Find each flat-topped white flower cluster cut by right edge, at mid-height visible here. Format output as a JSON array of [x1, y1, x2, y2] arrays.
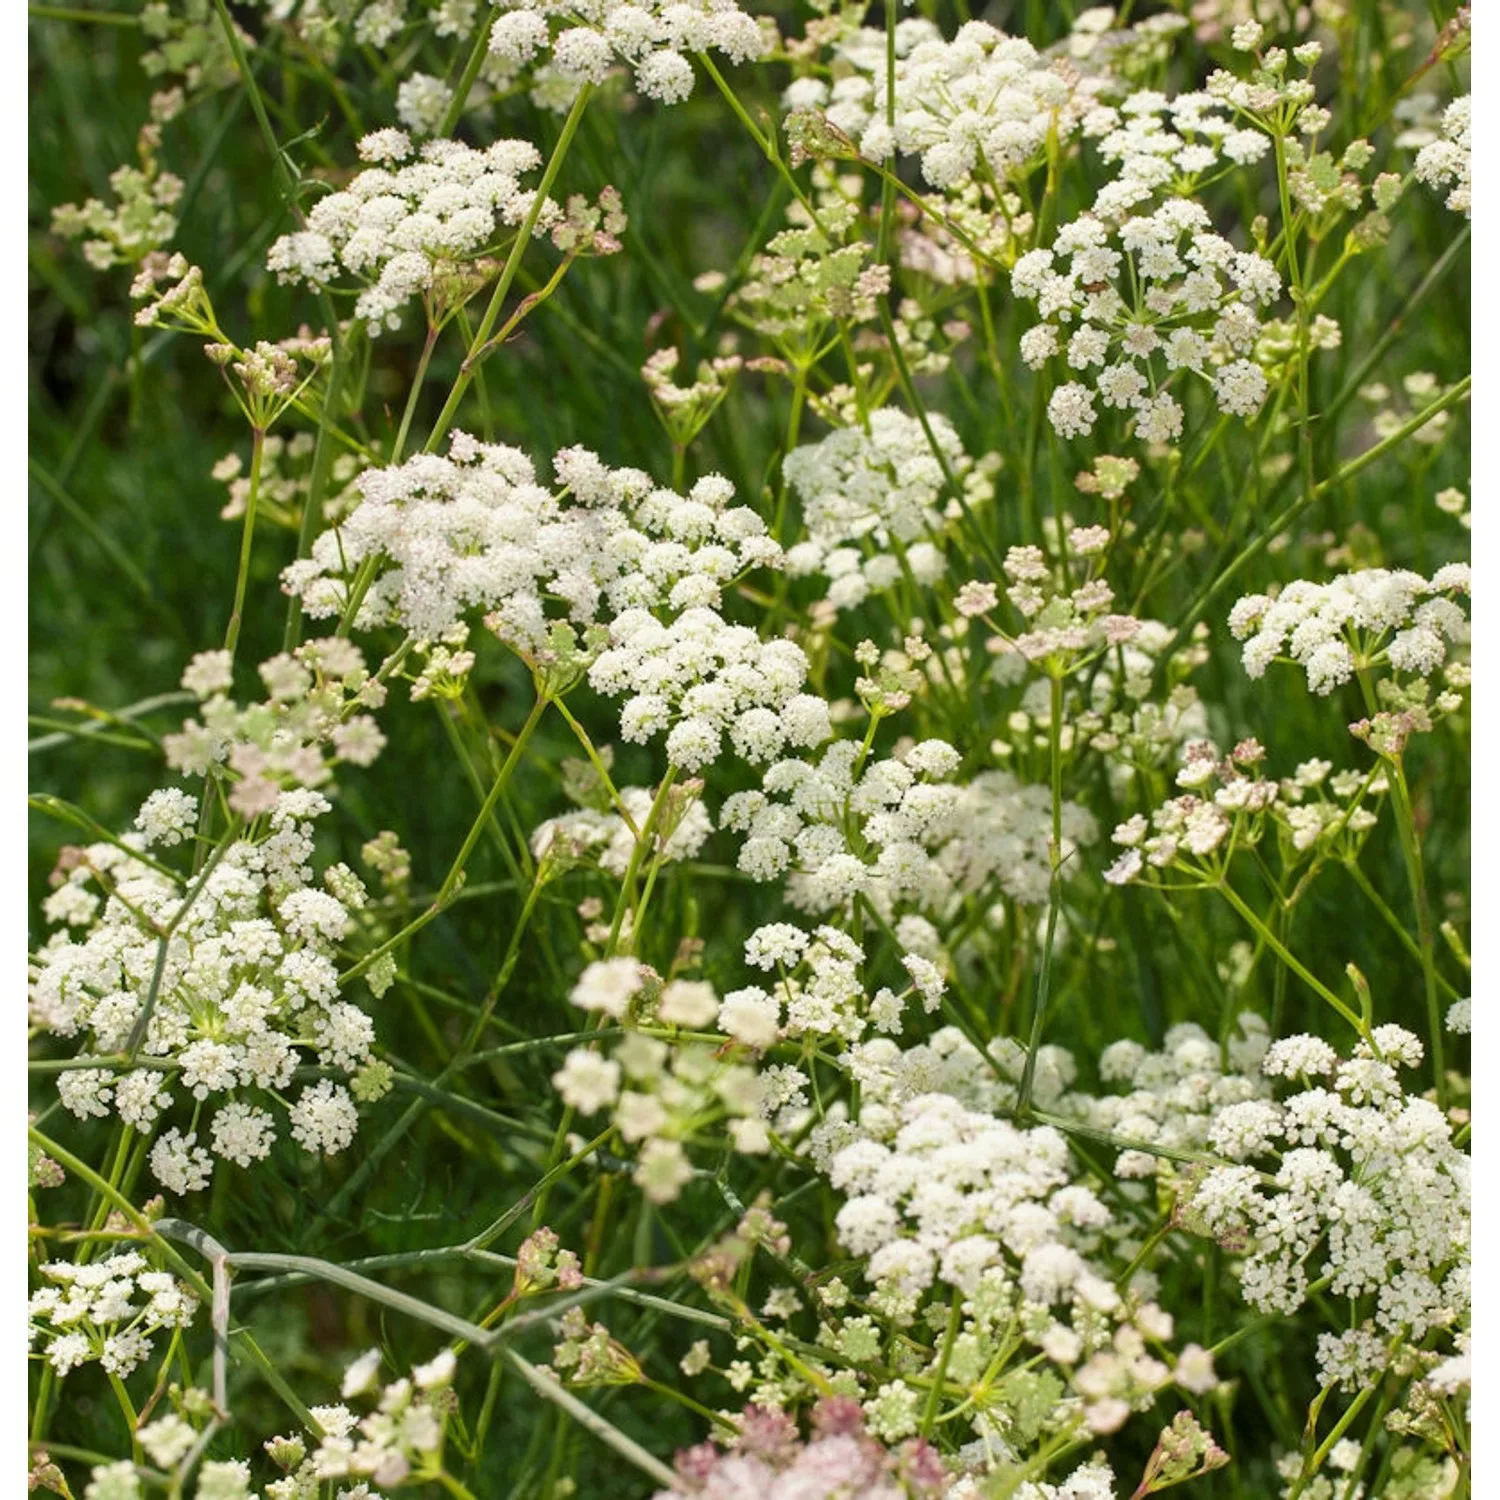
[[1229, 563, 1470, 696]]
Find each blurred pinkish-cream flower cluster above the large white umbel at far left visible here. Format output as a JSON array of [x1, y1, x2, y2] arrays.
[[162, 636, 386, 819]]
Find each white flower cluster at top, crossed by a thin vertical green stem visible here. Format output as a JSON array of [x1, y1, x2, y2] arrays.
[[810, 20, 1079, 191]]
